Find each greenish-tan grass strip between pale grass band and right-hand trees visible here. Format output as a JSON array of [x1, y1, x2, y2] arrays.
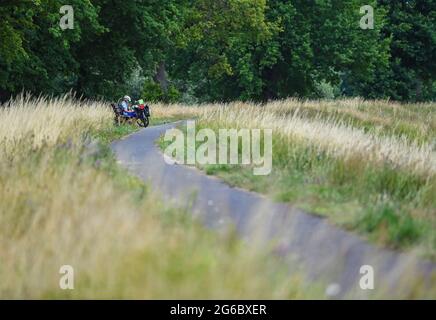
[[266, 98, 436, 142]]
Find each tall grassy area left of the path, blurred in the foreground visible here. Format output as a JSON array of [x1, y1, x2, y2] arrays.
[[0, 95, 323, 299]]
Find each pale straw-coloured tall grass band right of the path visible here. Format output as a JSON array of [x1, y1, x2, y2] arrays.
[[201, 100, 436, 176]]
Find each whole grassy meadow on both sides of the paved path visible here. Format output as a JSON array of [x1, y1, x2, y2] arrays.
[[0, 96, 436, 299]]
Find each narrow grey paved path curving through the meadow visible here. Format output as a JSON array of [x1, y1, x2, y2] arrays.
[[112, 123, 436, 298]]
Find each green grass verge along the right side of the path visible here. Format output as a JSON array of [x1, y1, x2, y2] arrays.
[[159, 121, 436, 258]]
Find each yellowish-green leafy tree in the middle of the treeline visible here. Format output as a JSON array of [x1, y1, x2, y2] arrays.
[[171, 0, 277, 100]]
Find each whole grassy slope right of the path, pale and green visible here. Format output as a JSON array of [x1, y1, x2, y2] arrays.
[[160, 99, 436, 258]]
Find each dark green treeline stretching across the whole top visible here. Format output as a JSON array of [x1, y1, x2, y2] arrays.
[[0, 0, 436, 102]]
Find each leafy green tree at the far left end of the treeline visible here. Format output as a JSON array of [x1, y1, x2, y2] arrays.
[[0, 0, 101, 100]]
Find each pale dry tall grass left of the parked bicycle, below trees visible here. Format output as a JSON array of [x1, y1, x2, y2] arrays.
[[0, 95, 113, 153]]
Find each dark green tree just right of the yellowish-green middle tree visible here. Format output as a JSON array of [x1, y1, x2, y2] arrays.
[[264, 0, 388, 98]]
